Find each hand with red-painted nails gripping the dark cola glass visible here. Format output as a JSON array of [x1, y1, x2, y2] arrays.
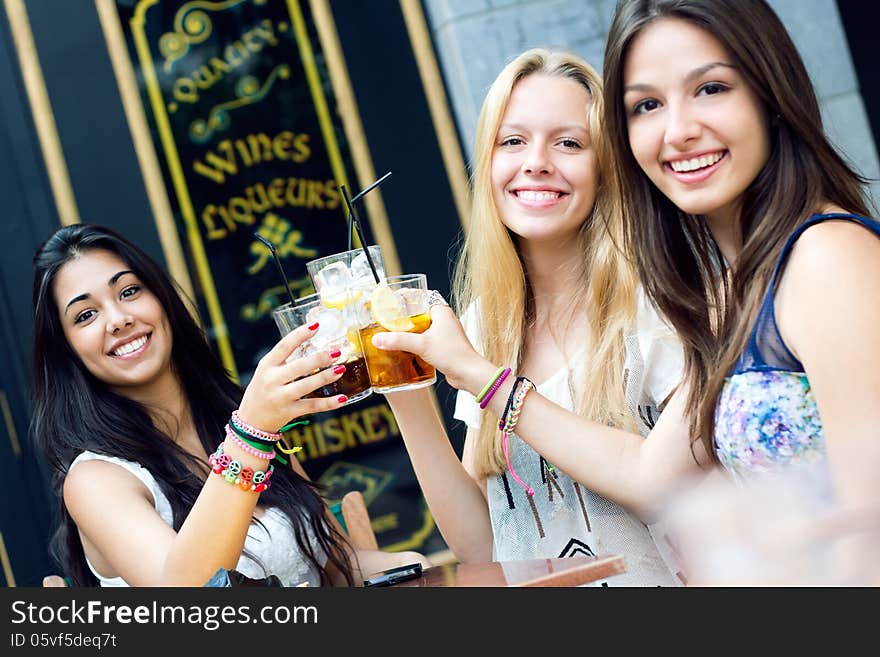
[[238, 324, 347, 431]]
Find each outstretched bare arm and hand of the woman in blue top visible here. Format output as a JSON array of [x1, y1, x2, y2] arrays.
[[373, 305, 708, 521]]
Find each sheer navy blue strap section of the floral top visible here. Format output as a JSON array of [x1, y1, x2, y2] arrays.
[[732, 213, 880, 374]]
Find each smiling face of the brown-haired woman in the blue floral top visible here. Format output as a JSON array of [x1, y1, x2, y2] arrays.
[[623, 18, 770, 223]]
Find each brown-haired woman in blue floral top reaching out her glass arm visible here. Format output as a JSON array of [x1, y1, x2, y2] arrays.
[[374, 0, 880, 584]]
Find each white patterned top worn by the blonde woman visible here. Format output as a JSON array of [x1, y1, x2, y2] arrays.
[[454, 289, 684, 586]]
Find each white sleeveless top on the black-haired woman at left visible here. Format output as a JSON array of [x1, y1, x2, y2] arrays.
[[70, 452, 327, 586]]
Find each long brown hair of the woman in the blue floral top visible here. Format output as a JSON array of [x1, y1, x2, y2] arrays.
[[604, 0, 868, 459]]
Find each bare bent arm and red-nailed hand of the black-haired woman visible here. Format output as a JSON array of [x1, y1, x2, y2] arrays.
[[64, 327, 354, 586]]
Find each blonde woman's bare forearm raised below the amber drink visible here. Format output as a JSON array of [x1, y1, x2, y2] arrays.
[[386, 388, 492, 562]]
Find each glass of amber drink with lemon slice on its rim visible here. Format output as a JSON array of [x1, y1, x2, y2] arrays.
[[360, 274, 437, 393]]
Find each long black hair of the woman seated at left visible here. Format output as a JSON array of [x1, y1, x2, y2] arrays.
[[31, 225, 353, 585]]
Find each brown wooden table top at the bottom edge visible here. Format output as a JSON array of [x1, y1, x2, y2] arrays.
[[395, 555, 626, 588]]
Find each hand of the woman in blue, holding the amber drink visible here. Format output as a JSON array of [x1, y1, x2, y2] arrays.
[[373, 304, 495, 392]]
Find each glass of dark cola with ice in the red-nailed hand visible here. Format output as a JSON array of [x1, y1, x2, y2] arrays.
[[272, 294, 373, 405]]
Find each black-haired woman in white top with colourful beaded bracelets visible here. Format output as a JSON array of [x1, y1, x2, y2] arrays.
[[32, 225, 422, 586]]
